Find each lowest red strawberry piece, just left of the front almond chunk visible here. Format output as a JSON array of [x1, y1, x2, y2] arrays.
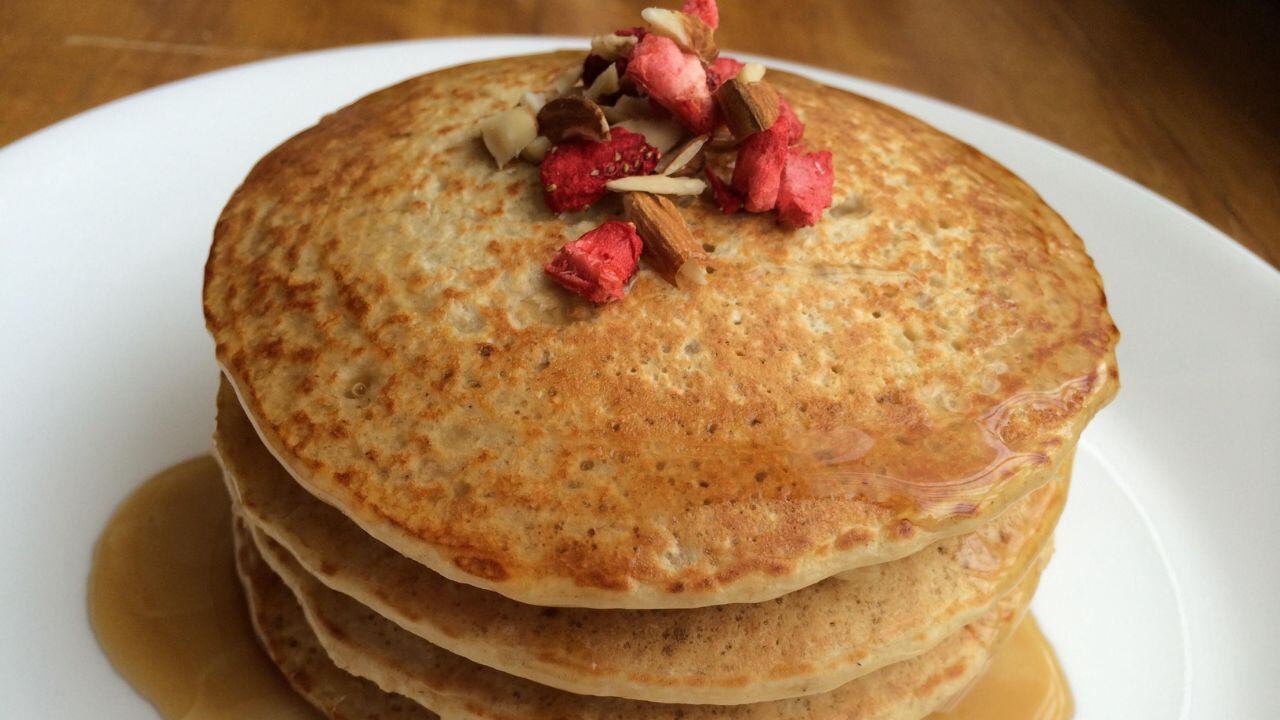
[[543, 220, 644, 302]]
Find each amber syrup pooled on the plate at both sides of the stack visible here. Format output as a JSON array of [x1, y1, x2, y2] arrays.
[[88, 456, 1074, 720]]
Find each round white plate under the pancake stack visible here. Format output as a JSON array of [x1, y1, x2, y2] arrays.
[[0, 38, 1280, 720]]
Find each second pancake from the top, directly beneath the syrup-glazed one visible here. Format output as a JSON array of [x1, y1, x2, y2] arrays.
[[215, 376, 1068, 705]]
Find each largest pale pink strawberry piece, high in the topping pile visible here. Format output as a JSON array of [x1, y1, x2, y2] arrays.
[[627, 33, 716, 135]]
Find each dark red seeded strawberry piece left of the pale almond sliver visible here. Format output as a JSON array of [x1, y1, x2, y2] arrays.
[[541, 128, 659, 213]]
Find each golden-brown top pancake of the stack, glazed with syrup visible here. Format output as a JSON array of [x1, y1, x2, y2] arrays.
[[205, 54, 1117, 607]]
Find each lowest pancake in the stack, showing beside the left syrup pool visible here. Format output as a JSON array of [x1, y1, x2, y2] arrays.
[[236, 504, 438, 720]]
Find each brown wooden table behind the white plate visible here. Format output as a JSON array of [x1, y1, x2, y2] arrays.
[[0, 0, 1280, 265]]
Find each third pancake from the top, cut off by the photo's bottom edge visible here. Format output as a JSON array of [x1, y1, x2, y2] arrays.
[[238, 509, 1039, 720]]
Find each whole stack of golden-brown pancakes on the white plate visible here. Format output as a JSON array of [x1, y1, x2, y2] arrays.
[[205, 54, 1117, 720]]
